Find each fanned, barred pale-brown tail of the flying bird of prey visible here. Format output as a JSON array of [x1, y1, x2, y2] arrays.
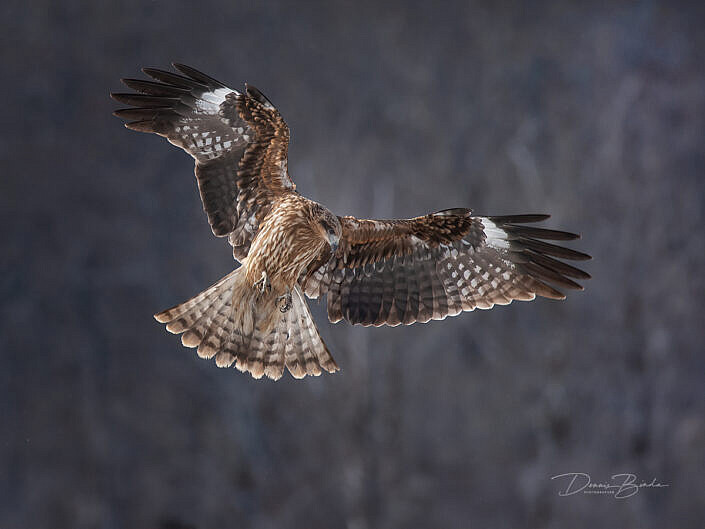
[[154, 266, 338, 380]]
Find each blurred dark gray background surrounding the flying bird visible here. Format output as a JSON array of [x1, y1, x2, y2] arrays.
[[0, 0, 705, 529]]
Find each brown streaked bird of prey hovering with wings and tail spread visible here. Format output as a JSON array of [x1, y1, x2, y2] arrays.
[[111, 63, 590, 380]]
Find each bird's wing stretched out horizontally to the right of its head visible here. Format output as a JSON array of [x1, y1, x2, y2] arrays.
[[300, 209, 590, 326]]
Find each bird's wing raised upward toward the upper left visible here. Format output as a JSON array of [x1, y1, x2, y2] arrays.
[[111, 63, 296, 259]]
